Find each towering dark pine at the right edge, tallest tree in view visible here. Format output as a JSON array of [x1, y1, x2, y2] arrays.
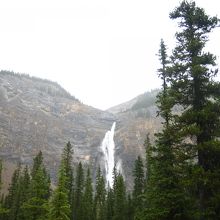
[[170, 1, 220, 219]]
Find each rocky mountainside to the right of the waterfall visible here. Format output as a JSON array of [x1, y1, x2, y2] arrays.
[[108, 90, 161, 188]]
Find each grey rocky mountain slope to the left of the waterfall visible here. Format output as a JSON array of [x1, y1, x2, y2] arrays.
[[0, 71, 115, 181]]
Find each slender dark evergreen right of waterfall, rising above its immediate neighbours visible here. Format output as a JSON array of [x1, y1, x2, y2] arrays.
[[133, 156, 145, 215]]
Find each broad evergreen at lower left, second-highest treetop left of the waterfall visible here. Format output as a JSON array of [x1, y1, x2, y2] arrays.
[[22, 151, 50, 220]]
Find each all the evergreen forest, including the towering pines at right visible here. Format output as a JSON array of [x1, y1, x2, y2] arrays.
[[0, 1, 220, 220]]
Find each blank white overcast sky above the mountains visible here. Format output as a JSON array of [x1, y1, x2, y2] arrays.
[[0, 0, 220, 109]]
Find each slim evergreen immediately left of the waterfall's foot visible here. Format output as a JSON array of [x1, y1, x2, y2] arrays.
[[94, 167, 106, 220]]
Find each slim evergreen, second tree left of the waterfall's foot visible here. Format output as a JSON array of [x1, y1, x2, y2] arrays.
[[82, 168, 94, 220]]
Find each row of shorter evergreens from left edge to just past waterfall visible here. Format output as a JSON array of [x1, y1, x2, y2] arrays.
[[0, 142, 144, 220]]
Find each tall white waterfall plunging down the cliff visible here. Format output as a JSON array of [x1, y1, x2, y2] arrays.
[[101, 122, 116, 187]]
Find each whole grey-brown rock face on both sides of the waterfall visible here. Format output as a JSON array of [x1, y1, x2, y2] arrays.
[[0, 71, 160, 189]]
